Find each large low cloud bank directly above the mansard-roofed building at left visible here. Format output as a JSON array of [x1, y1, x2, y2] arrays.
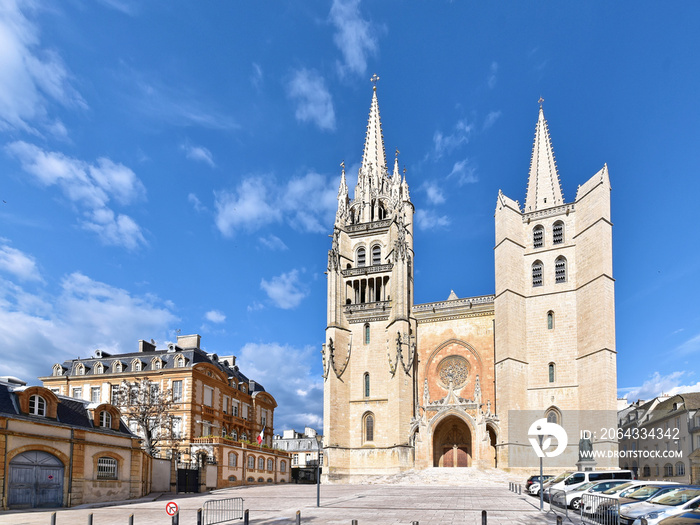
[[0, 273, 178, 382]]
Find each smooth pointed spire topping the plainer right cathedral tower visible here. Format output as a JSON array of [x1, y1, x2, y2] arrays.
[[525, 103, 564, 213]]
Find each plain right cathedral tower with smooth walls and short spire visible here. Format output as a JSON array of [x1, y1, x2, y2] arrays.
[[494, 106, 617, 468]]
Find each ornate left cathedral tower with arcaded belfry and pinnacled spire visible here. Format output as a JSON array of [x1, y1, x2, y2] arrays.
[[323, 82, 416, 479]]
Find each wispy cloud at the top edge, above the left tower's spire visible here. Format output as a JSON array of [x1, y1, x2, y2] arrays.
[[329, 0, 385, 77]]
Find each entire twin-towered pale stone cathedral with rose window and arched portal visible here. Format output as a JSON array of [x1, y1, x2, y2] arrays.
[[322, 84, 617, 481]]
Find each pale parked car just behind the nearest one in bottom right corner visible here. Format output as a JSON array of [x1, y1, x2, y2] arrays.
[[620, 485, 700, 525]]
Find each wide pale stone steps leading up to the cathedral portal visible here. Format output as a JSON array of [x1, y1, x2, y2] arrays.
[[362, 467, 525, 489]]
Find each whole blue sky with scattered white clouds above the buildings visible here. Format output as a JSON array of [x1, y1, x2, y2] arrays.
[[0, 0, 700, 431]]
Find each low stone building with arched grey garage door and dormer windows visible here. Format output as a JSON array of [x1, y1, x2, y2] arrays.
[[0, 378, 151, 509]]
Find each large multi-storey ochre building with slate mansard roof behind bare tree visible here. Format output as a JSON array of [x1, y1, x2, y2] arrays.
[[40, 335, 289, 487]]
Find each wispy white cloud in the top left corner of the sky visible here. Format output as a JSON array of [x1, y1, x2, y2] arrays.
[[0, 0, 86, 131]]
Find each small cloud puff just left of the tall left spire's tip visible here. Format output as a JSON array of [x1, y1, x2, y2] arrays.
[[287, 68, 335, 131]]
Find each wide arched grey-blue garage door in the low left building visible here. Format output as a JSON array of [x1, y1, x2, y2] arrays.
[[8, 450, 63, 508]]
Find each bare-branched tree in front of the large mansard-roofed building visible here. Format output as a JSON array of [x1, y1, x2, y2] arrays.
[[114, 377, 182, 455]]
